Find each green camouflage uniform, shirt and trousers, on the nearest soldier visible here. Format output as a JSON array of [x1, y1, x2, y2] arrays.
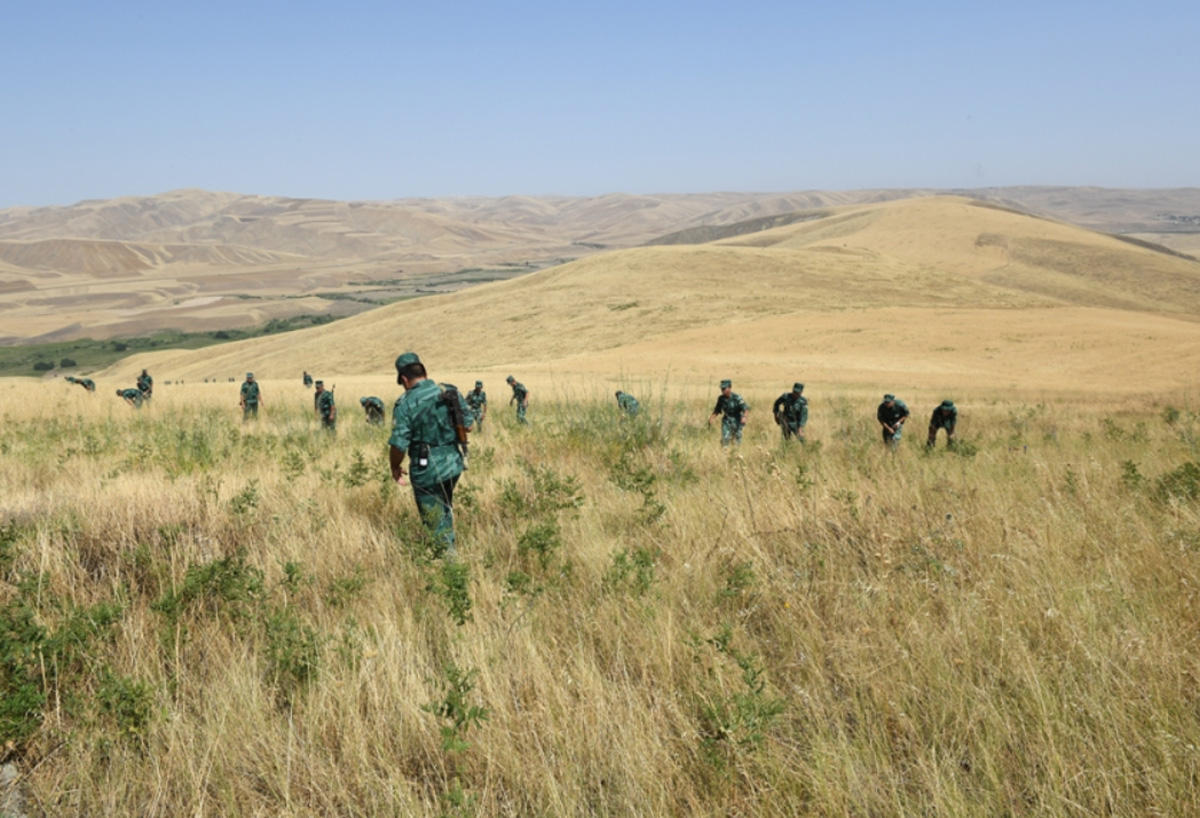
[[388, 376, 473, 557]]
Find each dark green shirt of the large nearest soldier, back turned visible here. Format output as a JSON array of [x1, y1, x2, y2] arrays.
[[388, 378, 470, 487]]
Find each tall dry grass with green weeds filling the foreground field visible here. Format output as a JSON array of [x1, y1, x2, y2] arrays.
[[0, 385, 1200, 816]]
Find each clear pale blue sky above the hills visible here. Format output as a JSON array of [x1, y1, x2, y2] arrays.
[[0, 0, 1200, 207]]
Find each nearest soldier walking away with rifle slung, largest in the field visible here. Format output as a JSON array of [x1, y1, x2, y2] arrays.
[[388, 353, 473, 559]]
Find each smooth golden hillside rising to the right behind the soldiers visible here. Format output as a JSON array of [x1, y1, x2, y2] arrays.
[[100, 197, 1200, 391]]
